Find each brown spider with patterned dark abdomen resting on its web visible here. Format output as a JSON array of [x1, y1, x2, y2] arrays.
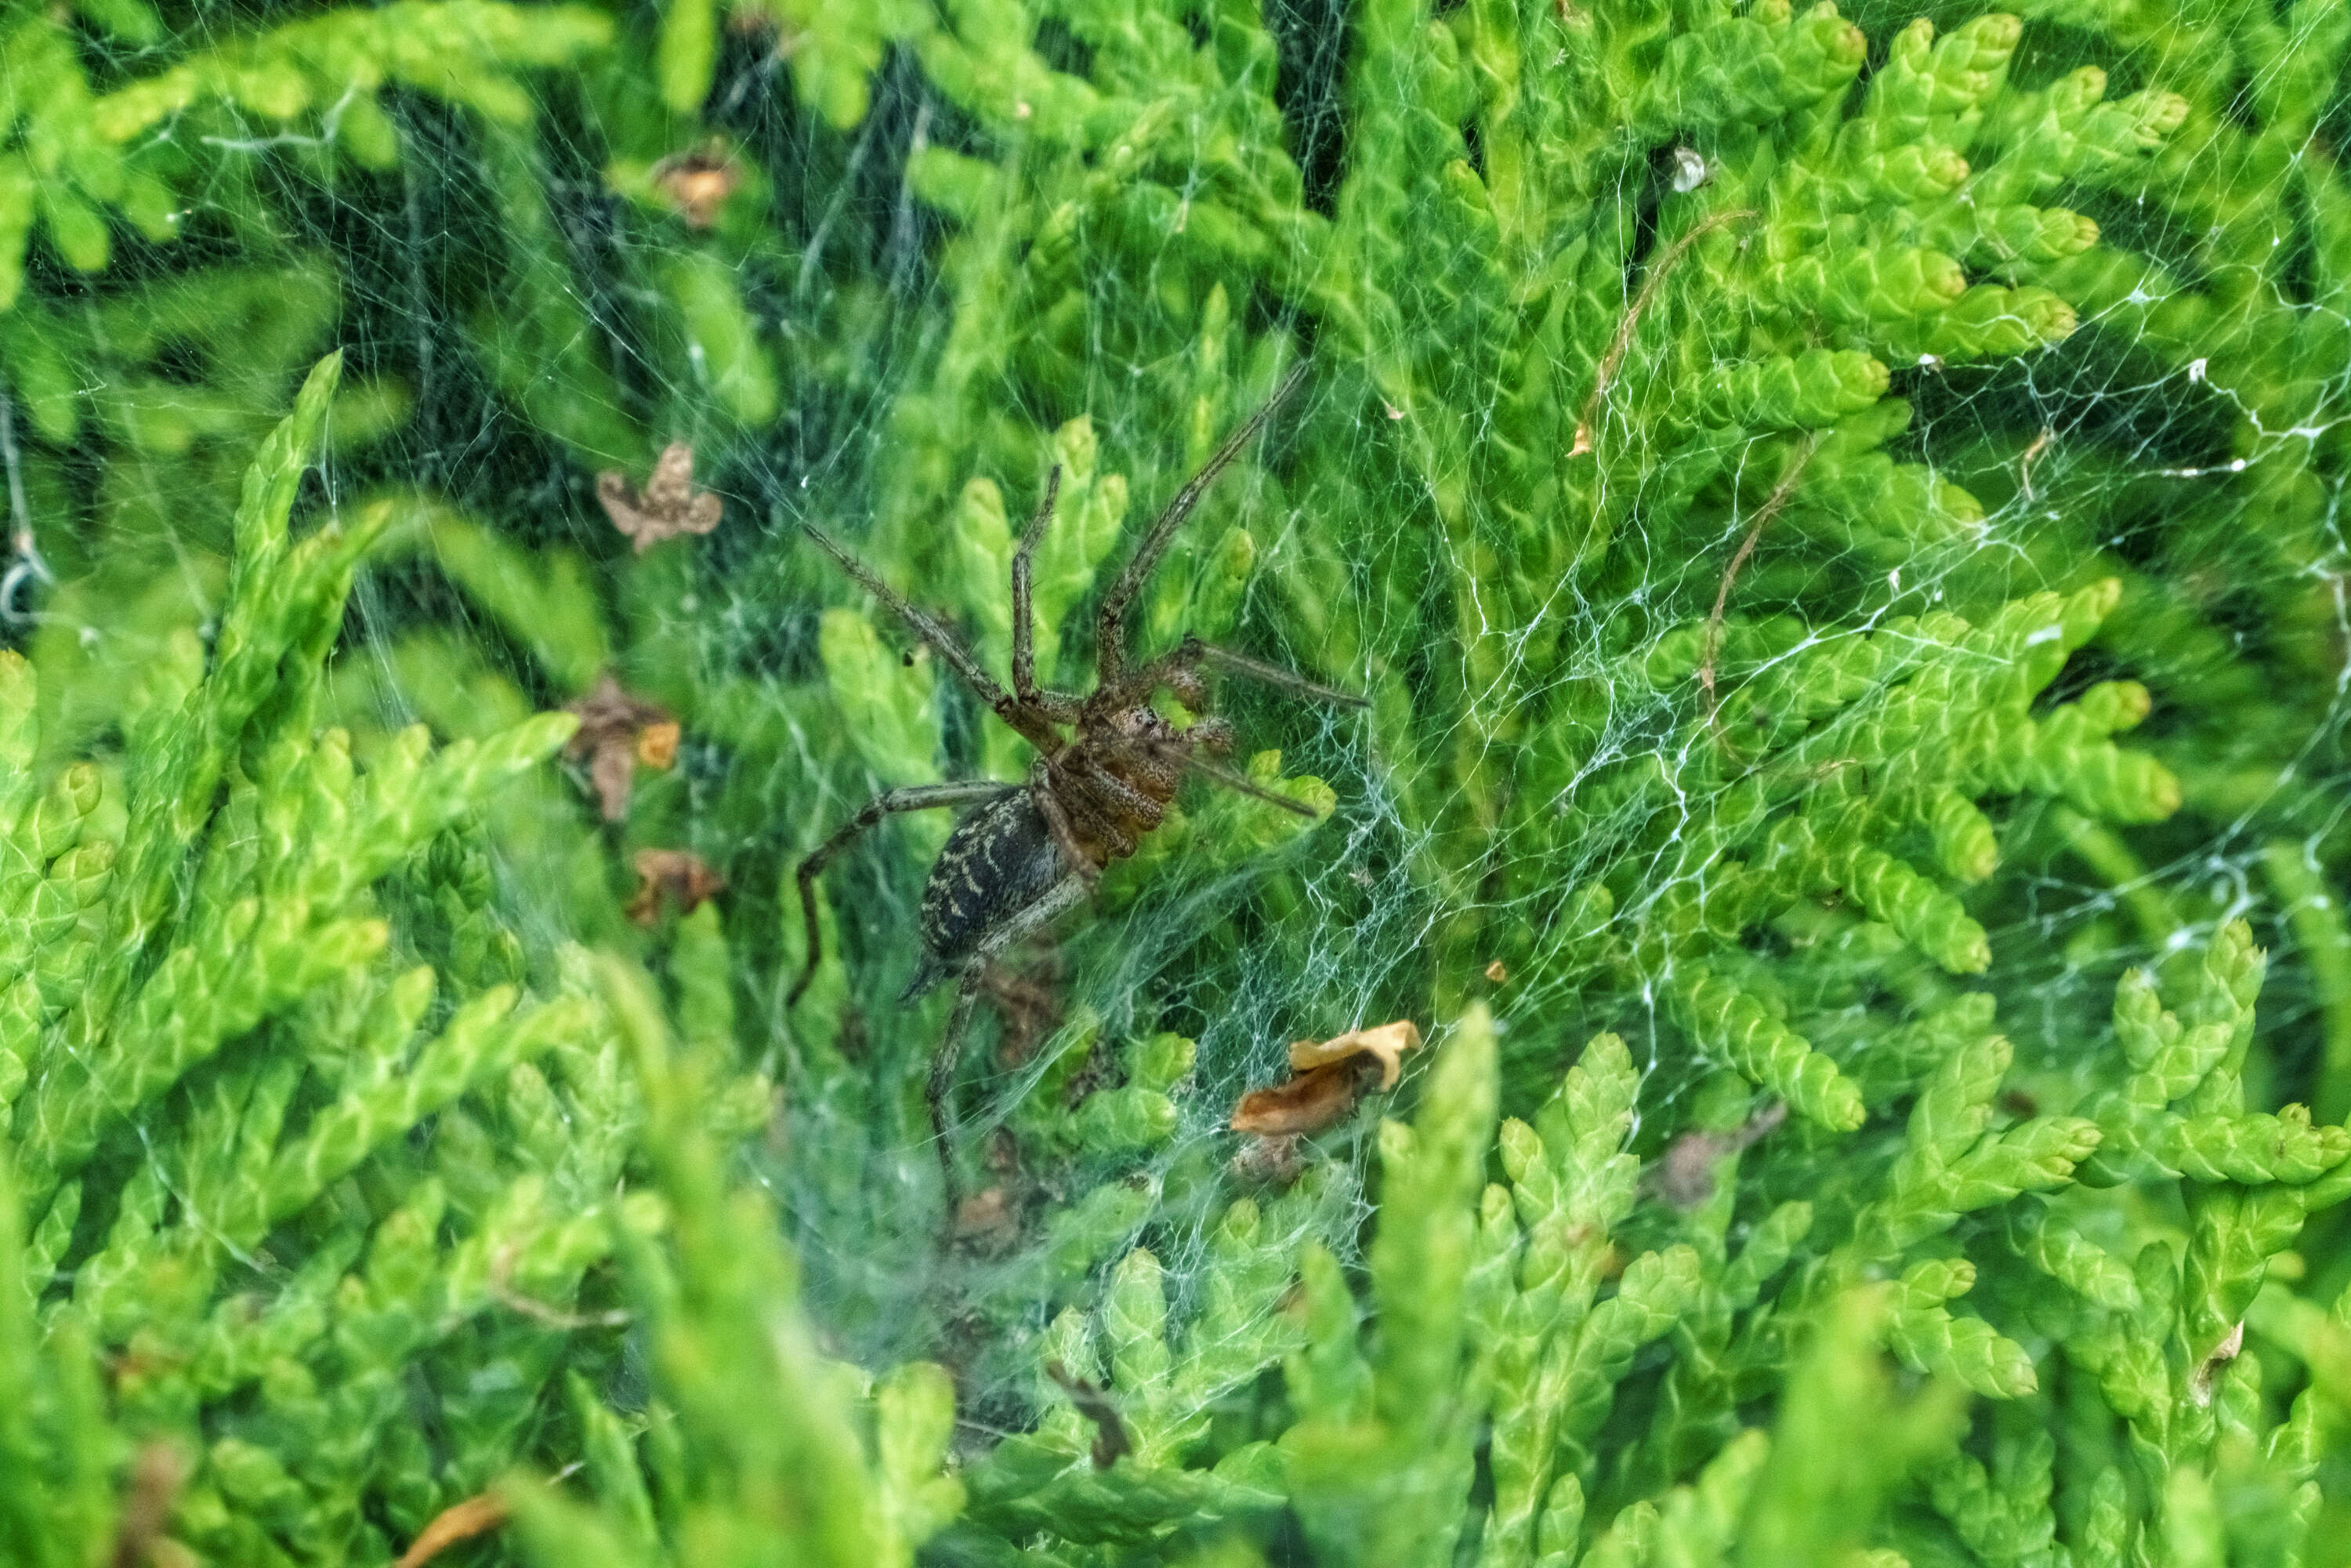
[[785, 364, 1364, 1213]]
